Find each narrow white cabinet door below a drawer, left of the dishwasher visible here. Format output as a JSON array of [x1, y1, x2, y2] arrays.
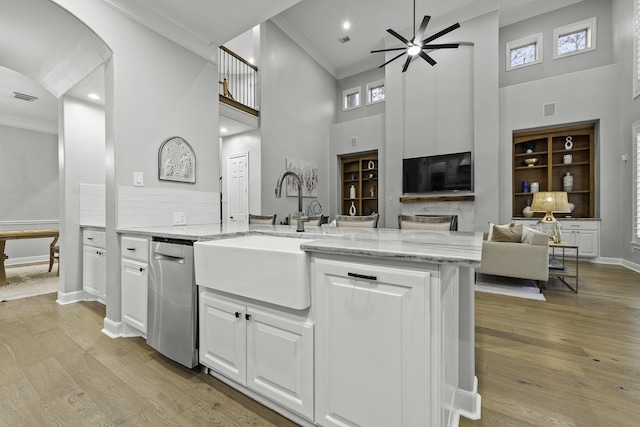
[[121, 258, 149, 334]]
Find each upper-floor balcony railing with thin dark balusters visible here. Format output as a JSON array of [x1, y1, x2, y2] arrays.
[[218, 46, 260, 116]]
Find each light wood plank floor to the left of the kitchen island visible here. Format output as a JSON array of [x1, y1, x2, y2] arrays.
[[0, 294, 296, 427]]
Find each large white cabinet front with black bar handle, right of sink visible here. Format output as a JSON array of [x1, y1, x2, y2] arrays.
[[313, 260, 430, 427]]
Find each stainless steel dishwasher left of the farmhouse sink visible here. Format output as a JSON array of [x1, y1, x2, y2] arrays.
[[147, 237, 198, 368]]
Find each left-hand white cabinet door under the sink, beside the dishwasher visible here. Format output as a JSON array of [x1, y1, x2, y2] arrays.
[[199, 291, 247, 386]]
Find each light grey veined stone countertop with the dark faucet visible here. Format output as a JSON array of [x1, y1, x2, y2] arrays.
[[117, 224, 482, 267]]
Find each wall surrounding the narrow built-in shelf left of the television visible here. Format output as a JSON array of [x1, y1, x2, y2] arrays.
[[330, 113, 386, 218]]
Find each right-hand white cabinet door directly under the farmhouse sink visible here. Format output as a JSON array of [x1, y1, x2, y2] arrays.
[[247, 308, 313, 419]]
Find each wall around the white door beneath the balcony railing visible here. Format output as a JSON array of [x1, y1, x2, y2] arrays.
[[220, 130, 262, 221]]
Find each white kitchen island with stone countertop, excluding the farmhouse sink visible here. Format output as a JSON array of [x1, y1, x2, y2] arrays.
[[119, 225, 482, 427]]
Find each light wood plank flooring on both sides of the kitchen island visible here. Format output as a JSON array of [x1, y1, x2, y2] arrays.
[[0, 263, 640, 427]]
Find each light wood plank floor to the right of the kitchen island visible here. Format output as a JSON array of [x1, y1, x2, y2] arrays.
[[460, 263, 640, 427]]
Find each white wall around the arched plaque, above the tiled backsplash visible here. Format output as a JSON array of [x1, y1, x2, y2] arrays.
[[55, 0, 220, 325]]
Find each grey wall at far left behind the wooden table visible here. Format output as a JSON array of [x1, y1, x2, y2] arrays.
[[0, 125, 58, 265]]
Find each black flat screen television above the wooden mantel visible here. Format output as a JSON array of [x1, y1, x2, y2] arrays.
[[402, 151, 473, 194]]
